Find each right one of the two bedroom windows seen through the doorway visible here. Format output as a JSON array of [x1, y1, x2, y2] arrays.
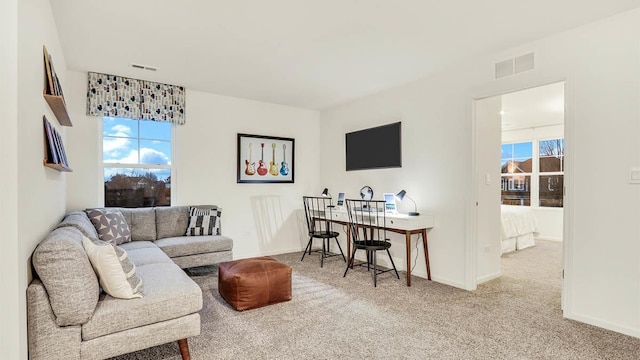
[[538, 139, 564, 207]]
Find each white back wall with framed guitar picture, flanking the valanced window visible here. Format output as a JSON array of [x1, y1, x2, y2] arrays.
[[67, 75, 322, 258]]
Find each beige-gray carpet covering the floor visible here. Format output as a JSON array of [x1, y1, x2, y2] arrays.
[[115, 241, 640, 360]]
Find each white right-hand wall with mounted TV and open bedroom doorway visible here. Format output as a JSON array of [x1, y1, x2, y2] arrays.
[[320, 9, 640, 336]]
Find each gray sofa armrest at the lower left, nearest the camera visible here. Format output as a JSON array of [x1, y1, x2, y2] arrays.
[[27, 279, 82, 360]]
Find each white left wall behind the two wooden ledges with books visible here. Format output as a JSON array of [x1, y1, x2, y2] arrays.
[[12, 0, 66, 359]]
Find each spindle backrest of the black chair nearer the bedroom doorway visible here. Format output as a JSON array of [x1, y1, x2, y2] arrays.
[[346, 200, 388, 244]]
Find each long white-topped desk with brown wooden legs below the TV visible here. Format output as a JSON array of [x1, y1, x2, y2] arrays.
[[331, 208, 435, 286]]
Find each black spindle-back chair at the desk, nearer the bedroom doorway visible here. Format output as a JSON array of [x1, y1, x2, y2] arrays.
[[343, 200, 400, 287]]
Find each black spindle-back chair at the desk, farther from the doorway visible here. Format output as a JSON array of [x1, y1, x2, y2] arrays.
[[300, 196, 347, 267]]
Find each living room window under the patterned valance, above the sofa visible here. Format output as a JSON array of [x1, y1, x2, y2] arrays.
[[102, 117, 172, 207]]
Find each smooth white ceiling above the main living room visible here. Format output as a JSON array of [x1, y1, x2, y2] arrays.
[[51, 0, 640, 109]]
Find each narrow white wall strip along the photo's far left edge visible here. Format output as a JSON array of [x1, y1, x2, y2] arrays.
[[0, 0, 20, 359]]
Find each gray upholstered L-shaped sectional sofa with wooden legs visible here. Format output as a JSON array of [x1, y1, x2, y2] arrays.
[[27, 206, 233, 360]]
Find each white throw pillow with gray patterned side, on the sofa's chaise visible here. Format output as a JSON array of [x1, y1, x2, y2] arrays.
[[82, 236, 142, 299]]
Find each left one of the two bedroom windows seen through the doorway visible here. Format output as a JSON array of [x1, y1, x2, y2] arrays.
[[501, 141, 533, 206]]
